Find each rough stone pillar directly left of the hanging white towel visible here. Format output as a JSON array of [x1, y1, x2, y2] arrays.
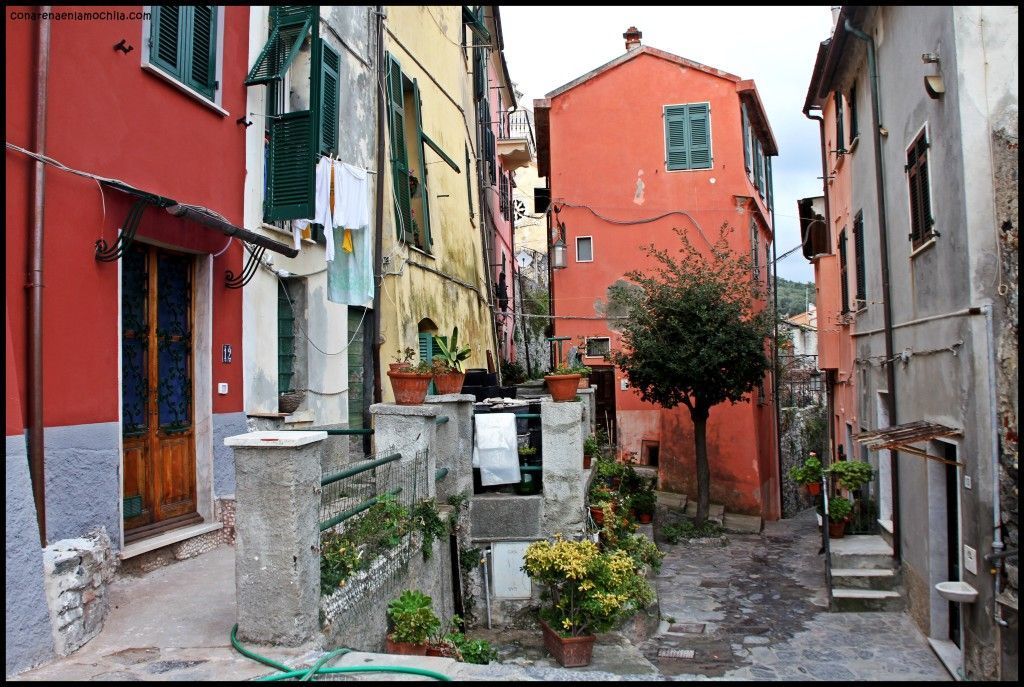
[[427, 393, 475, 504]]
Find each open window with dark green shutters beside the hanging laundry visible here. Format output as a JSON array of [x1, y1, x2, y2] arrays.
[[245, 5, 341, 224]]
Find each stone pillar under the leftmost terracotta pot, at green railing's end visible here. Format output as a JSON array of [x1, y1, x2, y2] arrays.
[[370, 403, 444, 503]]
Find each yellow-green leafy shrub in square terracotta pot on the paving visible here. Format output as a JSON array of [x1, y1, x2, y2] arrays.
[[522, 538, 654, 668]]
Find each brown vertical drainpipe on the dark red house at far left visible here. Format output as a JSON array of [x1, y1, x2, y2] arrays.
[[27, 5, 50, 547]]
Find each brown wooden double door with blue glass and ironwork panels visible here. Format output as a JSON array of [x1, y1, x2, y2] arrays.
[[121, 244, 202, 544]]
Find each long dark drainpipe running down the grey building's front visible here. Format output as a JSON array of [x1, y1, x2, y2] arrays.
[[843, 18, 903, 560]]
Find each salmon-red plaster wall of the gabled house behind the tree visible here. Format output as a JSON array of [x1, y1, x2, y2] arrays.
[[550, 54, 778, 518]]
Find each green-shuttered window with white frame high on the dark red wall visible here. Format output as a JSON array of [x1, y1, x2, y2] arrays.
[[142, 5, 223, 104]]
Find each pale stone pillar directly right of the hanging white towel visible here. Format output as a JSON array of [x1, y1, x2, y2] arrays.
[[541, 400, 585, 538]]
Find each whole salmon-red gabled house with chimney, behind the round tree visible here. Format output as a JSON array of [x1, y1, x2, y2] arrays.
[[535, 28, 779, 519]]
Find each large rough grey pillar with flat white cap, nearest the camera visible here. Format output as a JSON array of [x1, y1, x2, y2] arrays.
[[224, 431, 327, 646]]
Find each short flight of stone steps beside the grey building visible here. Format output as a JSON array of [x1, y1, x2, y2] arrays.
[[829, 534, 906, 611]]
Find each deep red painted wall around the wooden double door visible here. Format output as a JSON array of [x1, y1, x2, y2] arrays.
[[6, 7, 249, 432]]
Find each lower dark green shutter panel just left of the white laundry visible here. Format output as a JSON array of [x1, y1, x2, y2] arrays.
[[263, 110, 316, 221]]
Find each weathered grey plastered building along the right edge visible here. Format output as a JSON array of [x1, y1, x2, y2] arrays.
[[808, 6, 1018, 680]]
